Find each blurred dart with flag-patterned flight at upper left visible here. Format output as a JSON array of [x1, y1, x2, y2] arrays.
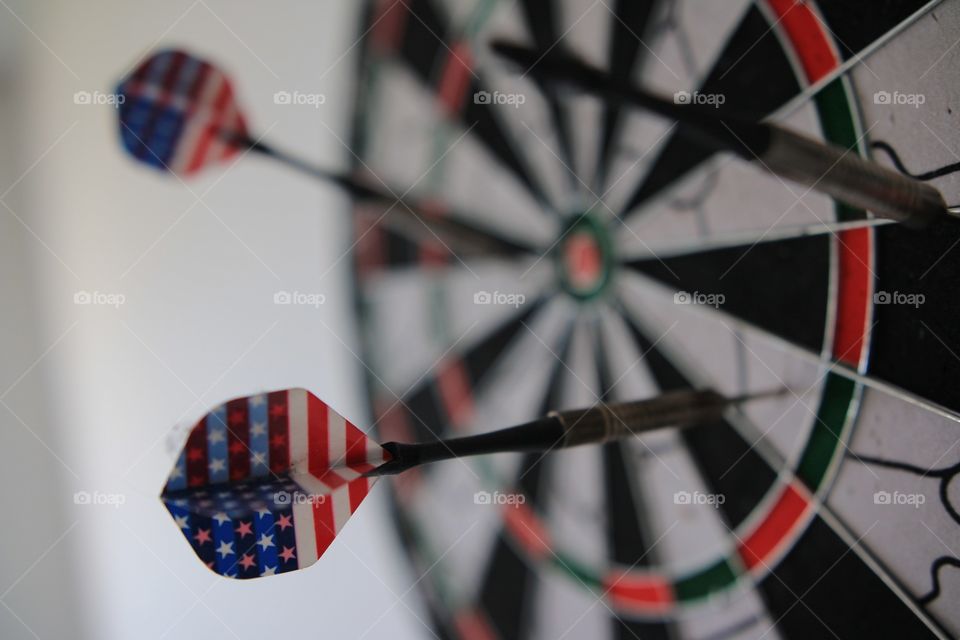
[[116, 50, 534, 256]]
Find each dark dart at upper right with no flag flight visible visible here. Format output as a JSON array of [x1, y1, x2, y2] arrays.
[[492, 41, 953, 227]]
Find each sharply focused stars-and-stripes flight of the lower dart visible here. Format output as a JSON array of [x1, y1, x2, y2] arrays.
[[161, 389, 389, 578]]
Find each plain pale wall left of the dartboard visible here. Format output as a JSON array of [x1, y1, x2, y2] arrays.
[[0, 0, 429, 639]]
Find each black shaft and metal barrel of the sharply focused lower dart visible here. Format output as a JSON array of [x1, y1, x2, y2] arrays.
[[370, 390, 744, 475]]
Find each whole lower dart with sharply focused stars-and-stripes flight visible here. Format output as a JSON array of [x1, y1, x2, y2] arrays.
[[161, 389, 784, 578]]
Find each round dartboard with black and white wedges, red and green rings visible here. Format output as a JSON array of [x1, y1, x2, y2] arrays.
[[353, 0, 960, 638]]
